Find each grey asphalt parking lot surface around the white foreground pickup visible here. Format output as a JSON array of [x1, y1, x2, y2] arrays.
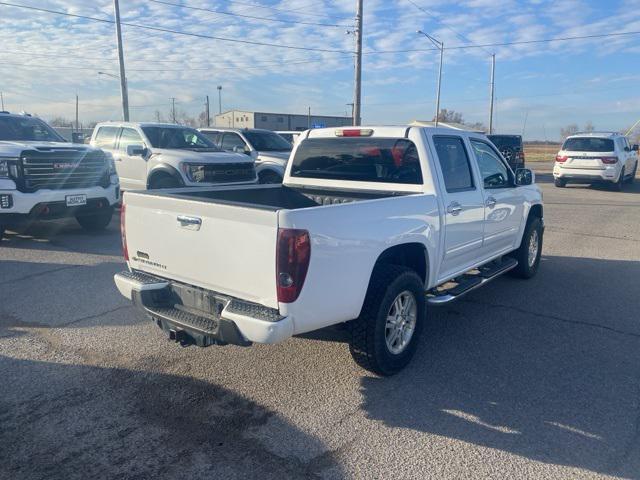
[[0, 169, 640, 479]]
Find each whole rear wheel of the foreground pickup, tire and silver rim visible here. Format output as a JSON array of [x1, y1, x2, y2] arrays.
[[349, 265, 426, 376]]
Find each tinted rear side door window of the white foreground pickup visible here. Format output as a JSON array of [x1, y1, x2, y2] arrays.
[[433, 135, 475, 193]]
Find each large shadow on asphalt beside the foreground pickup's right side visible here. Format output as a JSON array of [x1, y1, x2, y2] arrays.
[[361, 257, 640, 478]]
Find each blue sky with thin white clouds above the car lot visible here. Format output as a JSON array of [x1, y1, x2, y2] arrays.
[[0, 0, 640, 140]]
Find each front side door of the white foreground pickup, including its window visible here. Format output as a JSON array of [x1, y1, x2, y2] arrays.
[[470, 138, 525, 257]]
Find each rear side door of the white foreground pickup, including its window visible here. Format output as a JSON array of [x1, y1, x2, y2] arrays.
[[432, 135, 484, 280]]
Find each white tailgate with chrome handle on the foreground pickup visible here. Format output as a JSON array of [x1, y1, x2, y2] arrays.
[[124, 192, 278, 308]]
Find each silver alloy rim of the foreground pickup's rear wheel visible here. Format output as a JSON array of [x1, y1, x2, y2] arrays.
[[384, 290, 418, 355]]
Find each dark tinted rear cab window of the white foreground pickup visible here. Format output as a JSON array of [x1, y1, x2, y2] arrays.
[[291, 138, 422, 184]]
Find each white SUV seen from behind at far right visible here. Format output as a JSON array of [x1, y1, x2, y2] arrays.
[[553, 132, 638, 190]]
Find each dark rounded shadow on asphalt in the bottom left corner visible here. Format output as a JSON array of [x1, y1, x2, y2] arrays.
[[0, 355, 341, 480]]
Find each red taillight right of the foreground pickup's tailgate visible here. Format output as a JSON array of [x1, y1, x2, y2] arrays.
[[276, 228, 311, 303]]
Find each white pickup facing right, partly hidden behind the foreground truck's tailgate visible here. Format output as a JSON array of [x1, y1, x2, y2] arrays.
[[91, 122, 257, 190]]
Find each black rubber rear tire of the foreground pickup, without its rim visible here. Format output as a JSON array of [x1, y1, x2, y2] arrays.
[[349, 264, 426, 376]]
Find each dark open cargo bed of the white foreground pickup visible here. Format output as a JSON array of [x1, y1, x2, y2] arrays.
[[147, 185, 404, 211]]
